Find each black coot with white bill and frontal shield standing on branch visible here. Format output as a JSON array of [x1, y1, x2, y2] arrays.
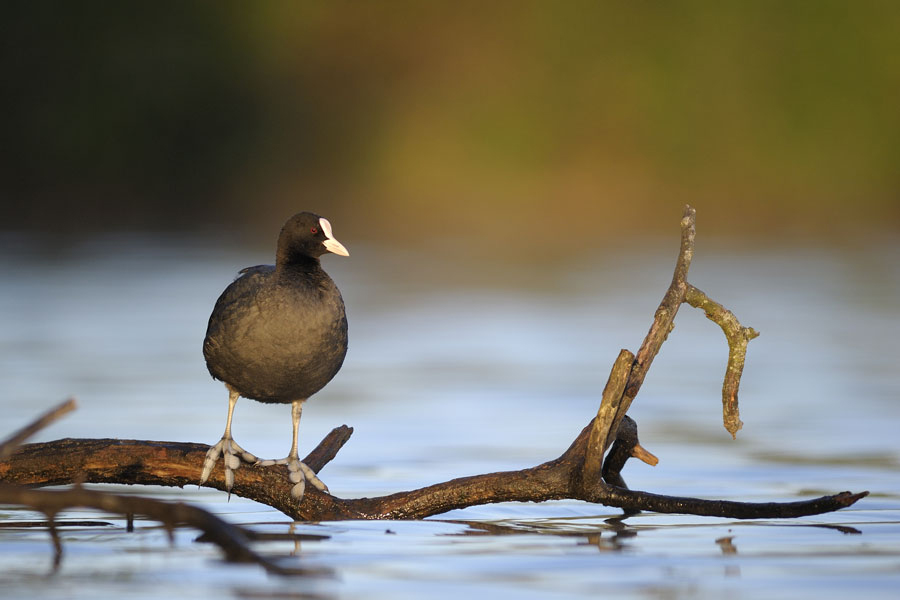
[[200, 212, 350, 501]]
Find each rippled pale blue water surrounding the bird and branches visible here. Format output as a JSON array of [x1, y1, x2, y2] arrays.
[[0, 232, 900, 598]]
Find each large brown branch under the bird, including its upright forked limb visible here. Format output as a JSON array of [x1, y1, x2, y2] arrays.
[[0, 206, 868, 520]]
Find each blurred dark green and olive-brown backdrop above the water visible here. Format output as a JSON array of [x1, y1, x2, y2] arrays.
[[0, 1, 900, 254]]
